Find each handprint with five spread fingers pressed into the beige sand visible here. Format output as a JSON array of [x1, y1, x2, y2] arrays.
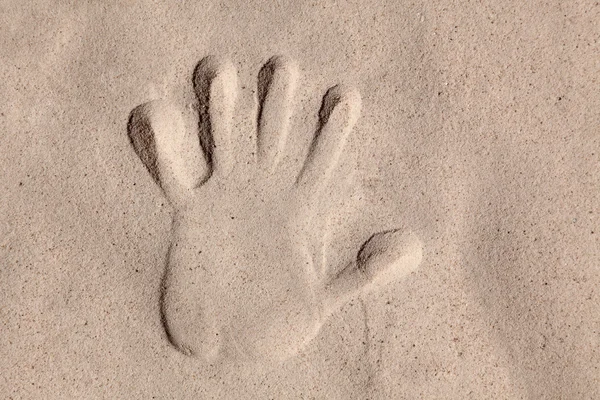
[[128, 57, 422, 364]]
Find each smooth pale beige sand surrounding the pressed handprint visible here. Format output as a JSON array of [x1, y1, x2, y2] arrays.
[[0, 0, 600, 399]]
